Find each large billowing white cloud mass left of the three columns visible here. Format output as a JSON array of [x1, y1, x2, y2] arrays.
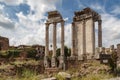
[[0, 0, 61, 45]]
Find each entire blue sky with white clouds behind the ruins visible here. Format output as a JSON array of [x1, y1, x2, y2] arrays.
[[0, 0, 120, 47]]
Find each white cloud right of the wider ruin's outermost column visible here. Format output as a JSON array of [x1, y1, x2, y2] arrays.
[[102, 13, 120, 47]]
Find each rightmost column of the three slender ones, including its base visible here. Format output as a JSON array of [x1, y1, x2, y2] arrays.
[[59, 21, 65, 70]]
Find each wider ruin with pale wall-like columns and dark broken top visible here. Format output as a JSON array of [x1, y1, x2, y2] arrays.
[[71, 8, 102, 60]]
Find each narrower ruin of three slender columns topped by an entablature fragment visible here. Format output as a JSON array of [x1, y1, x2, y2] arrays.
[[44, 11, 65, 69]]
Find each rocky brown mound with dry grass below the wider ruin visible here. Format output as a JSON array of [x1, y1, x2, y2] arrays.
[[72, 62, 110, 77]]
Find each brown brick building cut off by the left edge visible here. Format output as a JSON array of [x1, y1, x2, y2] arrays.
[[0, 36, 9, 50]]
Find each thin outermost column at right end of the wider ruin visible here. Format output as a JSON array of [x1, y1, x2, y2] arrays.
[[98, 20, 102, 47]]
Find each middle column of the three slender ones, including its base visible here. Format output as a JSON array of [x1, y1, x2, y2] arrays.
[[51, 23, 57, 67]]
